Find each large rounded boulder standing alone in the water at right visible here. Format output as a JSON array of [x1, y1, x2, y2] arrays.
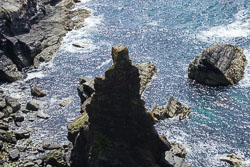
[[188, 45, 247, 86]]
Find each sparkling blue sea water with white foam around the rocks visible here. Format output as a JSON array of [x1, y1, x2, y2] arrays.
[[0, 0, 250, 167]]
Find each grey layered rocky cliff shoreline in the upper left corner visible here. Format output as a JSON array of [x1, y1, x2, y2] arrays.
[[0, 0, 89, 82]]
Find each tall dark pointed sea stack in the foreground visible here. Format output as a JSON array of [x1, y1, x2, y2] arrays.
[[71, 45, 171, 167]]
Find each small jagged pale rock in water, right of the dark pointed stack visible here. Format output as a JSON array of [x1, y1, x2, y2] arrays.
[[151, 97, 191, 121]]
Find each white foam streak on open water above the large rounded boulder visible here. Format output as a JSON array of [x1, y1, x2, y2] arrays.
[[197, 10, 250, 43]]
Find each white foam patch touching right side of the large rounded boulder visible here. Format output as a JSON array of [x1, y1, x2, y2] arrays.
[[239, 50, 250, 88]]
